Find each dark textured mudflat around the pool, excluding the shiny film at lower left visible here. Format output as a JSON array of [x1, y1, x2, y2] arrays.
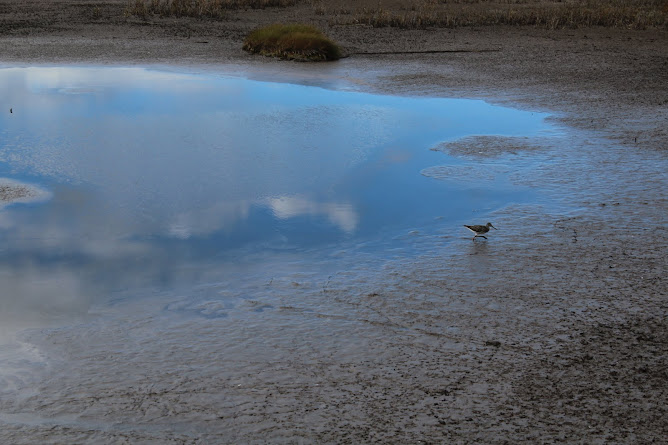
[[0, 0, 668, 443]]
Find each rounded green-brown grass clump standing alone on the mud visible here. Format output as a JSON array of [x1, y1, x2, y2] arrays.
[[243, 24, 341, 61]]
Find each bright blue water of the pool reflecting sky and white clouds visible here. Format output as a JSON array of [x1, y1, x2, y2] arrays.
[[0, 67, 549, 304]]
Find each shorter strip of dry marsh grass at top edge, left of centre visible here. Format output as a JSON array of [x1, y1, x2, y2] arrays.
[[125, 0, 298, 18]]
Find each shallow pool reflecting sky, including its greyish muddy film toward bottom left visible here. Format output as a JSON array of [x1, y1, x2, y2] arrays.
[[0, 67, 559, 438]]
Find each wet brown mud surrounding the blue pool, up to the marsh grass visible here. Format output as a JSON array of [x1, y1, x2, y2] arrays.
[[0, 2, 668, 444]]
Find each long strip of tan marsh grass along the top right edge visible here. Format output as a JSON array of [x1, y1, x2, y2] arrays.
[[344, 0, 668, 29]]
